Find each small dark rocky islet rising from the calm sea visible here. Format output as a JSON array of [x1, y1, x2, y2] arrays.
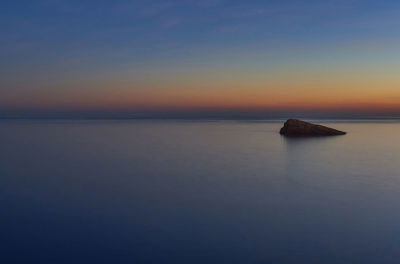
[[279, 119, 346, 137]]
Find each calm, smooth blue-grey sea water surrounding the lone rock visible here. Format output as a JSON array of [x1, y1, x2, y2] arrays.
[[0, 121, 400, 264]]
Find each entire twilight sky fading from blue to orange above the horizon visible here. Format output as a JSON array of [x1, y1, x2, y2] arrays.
[[0, 0, 400, 118]]
